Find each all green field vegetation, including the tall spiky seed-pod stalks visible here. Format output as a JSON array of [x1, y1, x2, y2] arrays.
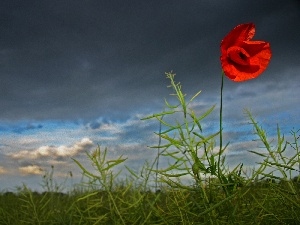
[[0, 74, 300, 225]]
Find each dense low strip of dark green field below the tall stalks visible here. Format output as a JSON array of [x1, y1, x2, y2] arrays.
[[0, 179, 300, 225]]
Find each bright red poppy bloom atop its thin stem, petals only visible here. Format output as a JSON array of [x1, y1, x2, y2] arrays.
[[221, 23, 272, 82]]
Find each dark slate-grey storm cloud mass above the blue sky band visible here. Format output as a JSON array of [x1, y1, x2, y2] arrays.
[[0, 0, 300, 121]]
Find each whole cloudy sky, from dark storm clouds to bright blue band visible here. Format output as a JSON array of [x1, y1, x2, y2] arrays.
[[0, 0, 300, 190]]
